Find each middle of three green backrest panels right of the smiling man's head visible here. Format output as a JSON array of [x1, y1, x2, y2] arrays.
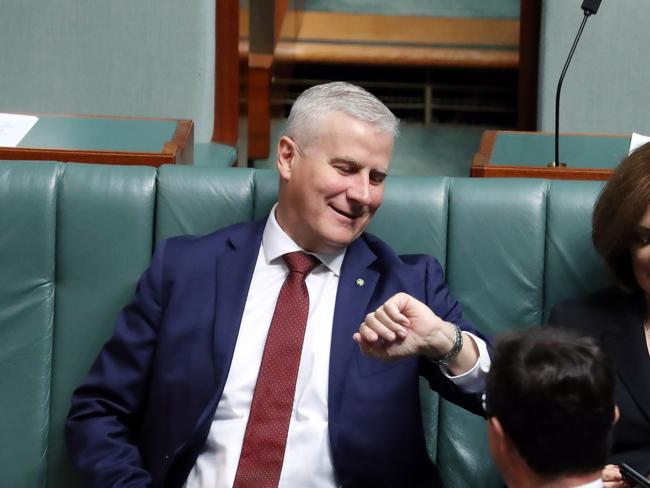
[[438, 178, 548, 487]]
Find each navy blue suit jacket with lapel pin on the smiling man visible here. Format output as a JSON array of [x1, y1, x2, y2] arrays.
[[66, 221, 482, 487]]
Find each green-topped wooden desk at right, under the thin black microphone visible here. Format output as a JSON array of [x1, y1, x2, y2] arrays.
[[470, 130, 631, 180]]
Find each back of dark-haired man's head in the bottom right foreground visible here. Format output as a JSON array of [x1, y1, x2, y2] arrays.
[[485, 327, 618, 487]]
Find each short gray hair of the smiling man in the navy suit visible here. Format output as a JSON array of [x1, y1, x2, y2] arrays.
[[284, 81, 399, 144]]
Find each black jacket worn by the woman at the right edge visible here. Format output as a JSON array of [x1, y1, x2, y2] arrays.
[[549, 287, 650, 474]]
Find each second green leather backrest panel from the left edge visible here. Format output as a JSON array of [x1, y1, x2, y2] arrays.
[[48, 164, 156, 487]]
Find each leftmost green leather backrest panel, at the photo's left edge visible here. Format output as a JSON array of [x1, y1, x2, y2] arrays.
[[0, 162, 59, 488]]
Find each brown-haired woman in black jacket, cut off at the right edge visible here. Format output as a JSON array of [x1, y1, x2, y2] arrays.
[[549, 143, 650, 487]]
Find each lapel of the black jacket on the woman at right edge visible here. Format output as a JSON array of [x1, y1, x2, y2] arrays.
[[603, 303, 650, 419]]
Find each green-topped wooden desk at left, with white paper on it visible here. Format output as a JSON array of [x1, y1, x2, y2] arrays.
[[0, 114, 194, 166]]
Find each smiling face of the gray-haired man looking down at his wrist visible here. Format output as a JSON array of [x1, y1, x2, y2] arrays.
[[276, 112, 393, 253]]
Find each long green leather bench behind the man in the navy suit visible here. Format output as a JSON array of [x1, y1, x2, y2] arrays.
[[0, 162, 607, 488]]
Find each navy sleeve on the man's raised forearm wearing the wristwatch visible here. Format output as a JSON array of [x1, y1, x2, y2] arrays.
[[420, 257, 490, 415]]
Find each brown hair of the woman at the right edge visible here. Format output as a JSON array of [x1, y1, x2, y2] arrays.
[[591, 142, 650, 292]]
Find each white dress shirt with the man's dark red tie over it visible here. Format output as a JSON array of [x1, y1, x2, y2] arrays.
[[185, 207, 490, 488]]
